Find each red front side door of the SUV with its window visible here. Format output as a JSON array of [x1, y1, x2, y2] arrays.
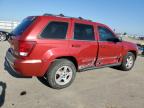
[[96, 26, 122, 66]]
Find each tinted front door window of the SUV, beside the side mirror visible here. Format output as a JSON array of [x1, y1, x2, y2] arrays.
[[98, 27, 115, 41]]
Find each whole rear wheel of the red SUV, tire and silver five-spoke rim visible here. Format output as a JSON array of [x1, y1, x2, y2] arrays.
[[46, 59, 76, 89]]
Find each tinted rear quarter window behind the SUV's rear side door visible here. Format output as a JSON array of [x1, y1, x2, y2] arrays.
[[41, 22, 68, 39]]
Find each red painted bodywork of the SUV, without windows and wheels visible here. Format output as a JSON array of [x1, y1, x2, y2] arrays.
[[5, 16, 137, 76]]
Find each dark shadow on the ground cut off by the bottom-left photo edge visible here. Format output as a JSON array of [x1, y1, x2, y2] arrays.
[[0, 81, 7, 108]]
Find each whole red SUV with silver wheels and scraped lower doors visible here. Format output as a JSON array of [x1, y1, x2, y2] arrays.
[[6, 14, 137, 89]]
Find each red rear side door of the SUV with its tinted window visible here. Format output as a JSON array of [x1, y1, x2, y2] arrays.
[[70, 20, 98, 69]]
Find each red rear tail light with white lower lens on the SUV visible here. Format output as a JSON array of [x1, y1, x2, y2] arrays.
[[16, 41, 36, 57]]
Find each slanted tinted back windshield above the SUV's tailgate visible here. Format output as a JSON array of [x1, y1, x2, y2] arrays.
[[11, 17, 36, 36]]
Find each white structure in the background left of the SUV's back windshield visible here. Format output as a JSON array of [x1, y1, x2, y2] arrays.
[[0, 20, 19, 30]]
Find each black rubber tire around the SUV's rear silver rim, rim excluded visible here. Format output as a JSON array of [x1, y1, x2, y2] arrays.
[[46, 59, 76, 89]]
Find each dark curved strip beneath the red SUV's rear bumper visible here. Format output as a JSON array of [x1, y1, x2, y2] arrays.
[[4, 60, 32, 78]]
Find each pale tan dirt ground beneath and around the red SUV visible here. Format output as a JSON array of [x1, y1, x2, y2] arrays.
[[0, 42, 144, 108]]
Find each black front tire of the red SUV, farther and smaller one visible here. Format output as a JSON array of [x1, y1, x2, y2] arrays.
[[119, 52, 135, 71]]
